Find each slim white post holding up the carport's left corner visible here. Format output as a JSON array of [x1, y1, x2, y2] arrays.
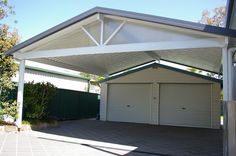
[[16, 60, 25, 128]]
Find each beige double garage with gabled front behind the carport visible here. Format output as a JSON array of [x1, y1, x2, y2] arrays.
[[100, 63, 221, 128]]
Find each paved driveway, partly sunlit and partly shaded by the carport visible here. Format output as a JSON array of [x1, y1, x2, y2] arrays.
[[0, 120, 223, 156]]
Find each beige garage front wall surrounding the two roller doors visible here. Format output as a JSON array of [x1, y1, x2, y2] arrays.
[[100, 67, 220, 128]]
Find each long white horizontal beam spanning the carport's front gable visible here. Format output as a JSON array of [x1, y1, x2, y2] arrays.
[[14, 39, 225, 59]]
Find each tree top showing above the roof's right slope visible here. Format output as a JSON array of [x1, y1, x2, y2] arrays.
[[199, 6, 226, 27]]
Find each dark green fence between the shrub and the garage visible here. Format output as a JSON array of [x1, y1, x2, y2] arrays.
[[5, 89, 100, 120]]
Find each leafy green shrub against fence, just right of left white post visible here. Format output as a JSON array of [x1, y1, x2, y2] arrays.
[[24, 82, 56, 119]]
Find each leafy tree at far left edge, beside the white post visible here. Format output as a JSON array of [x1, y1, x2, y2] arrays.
[[0, 0, 19, 121]]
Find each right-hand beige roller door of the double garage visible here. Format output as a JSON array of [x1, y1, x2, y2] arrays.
[[160, 84, 211, 128]]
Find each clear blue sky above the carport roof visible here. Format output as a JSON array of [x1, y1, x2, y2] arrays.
[[4, 0, 227, 41]]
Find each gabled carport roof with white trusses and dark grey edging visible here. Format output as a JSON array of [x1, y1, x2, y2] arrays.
[[6, 7, 236, 75]]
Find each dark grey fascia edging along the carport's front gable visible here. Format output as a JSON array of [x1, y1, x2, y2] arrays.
[[6, 7, 236, 55]]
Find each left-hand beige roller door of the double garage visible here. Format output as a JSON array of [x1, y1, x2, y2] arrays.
[[107, 84, 151, 123]]
